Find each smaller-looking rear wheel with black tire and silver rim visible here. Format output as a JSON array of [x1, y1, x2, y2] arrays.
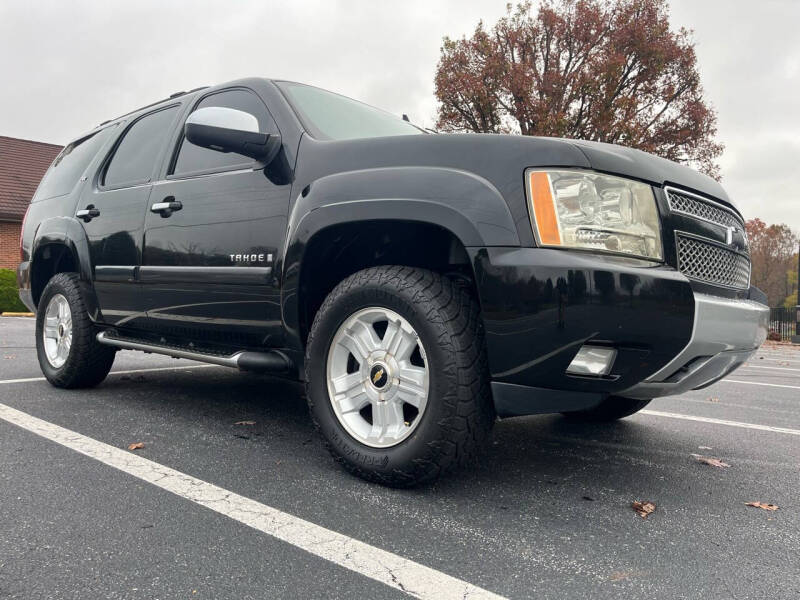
[[36, 273, 116, 388]]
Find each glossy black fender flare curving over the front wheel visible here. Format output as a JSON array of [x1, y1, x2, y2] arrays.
[[280, 167, 520, 349]]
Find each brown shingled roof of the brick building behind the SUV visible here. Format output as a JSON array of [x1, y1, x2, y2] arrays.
[[0, 135, 61, 221]]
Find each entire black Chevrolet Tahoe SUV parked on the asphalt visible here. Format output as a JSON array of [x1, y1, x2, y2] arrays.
[[18, 79, 768, 485]]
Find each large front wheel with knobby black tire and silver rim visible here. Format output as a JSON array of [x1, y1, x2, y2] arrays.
[[305, 266, 495, 487]]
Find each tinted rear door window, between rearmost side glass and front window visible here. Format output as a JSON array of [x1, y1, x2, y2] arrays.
[[103, 106, 178, 187]]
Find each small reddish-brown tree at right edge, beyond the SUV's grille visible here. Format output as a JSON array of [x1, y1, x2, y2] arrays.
[[745, 219, 797, 306]]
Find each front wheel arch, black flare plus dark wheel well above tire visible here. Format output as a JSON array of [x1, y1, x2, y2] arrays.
[[281, 167, 519, 349]]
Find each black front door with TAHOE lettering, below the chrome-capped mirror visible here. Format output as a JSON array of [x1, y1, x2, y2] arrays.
[[139, 88, 290, 348]]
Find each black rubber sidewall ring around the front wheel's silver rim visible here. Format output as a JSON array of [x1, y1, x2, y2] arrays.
[[306, 276, 466, 474]]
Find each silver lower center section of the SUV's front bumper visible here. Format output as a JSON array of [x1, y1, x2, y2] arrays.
[[619, 293, 769, 399]]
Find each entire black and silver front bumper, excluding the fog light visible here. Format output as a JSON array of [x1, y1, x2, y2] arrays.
[[468, 248, 769, 416]]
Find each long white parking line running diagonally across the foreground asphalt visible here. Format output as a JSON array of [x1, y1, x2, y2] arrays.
[[0, 404, 502, 599]]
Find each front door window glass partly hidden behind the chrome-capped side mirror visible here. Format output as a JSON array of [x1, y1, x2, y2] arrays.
[[170, 88, 272, 176]]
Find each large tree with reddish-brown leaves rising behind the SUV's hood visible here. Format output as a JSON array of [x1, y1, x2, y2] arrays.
[[435, 0, 723, 178]]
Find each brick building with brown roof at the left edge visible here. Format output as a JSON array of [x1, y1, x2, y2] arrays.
[[0, 135, 61, 269]]
